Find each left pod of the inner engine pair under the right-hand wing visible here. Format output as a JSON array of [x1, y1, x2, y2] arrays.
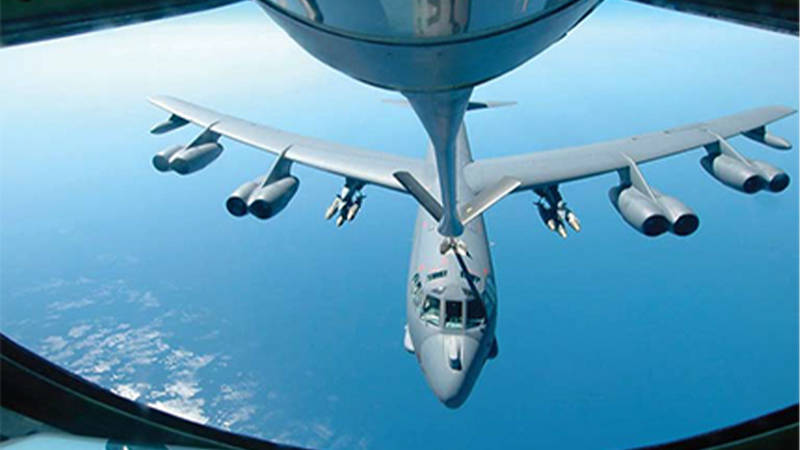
[[608, 186, 670, 236]]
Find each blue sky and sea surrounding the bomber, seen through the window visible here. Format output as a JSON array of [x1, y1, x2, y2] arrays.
[[0, 1, 798, 448]]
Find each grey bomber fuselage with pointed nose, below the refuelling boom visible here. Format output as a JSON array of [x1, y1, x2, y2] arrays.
[[406, 124, 497, 408]]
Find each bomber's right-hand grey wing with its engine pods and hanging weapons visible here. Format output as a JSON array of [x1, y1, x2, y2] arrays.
[[464, 106, 795, 238]]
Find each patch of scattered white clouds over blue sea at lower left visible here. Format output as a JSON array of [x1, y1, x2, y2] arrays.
[[19, 279, 378, 448]]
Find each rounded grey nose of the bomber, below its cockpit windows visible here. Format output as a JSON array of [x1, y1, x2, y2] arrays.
[[420, 334, 478, 408]]
